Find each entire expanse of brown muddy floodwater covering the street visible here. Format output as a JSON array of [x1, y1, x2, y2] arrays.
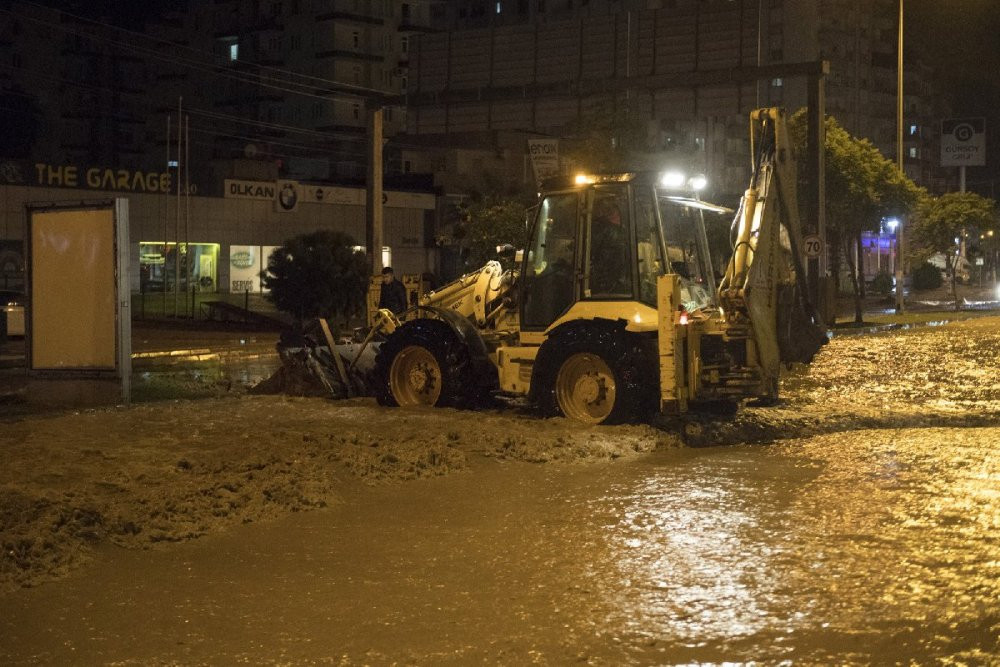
[[0, 317, 1000, 665]]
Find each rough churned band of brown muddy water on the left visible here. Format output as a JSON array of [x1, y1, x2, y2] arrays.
[[0, 396, 679, 589]]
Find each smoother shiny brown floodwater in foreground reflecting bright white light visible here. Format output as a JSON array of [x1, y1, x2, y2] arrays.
[[0, 427, 1000, 664]]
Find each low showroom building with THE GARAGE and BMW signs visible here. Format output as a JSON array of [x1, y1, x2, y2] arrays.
[[0, 172, 437, 293]]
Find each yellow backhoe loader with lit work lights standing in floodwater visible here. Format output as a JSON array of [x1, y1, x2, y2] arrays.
[[362, 109, 826, 424]]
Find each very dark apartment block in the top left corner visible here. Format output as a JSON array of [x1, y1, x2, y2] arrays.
[[0, 2, 150, 170]]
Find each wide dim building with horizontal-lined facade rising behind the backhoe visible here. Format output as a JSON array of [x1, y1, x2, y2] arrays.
[[407, 0, 941, 198]]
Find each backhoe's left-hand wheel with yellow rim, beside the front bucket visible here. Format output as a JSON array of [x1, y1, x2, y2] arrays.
[[375, 319, 479, 407]]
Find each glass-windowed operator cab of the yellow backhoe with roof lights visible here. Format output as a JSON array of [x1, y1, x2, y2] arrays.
[[520, 174, 715, 331]]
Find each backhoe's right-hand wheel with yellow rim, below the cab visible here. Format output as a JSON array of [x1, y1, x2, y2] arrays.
[[533, 325, 659, 424]]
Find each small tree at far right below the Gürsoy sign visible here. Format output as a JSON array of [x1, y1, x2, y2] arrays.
[[913, 192, 997, 310]]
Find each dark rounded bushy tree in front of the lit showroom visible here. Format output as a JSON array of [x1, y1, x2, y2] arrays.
[[261, 230, 369, 329]]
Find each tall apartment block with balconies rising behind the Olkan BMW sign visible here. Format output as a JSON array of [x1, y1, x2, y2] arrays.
[[148, 0, 446, 189]]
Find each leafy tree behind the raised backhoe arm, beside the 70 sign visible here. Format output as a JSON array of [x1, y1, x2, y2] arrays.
[[789, 109, 926, 324]]
